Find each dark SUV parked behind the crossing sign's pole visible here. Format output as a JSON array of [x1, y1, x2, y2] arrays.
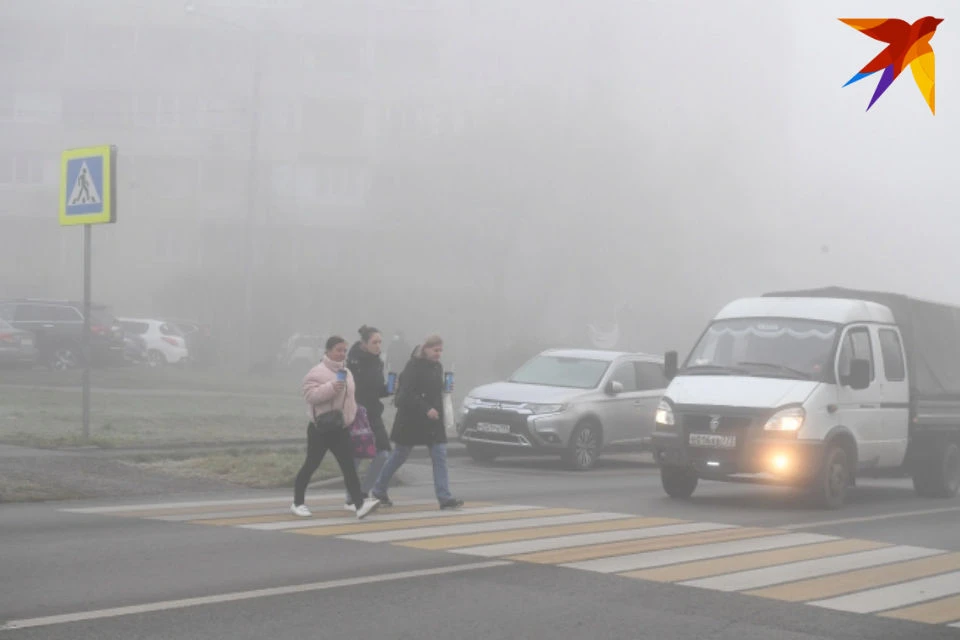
[[0, 298, 124, 370]]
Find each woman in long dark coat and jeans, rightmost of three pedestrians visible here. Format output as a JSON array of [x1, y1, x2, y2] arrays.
[[371, 336, 463, 509]]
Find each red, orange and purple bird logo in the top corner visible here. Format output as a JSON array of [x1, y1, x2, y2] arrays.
[[840, 16, 943, 115]]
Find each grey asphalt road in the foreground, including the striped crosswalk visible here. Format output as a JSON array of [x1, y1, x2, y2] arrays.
[[0, 457, 960, 640]]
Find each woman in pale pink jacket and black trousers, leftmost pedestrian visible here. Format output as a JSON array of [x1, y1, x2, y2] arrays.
[[290, 336, 380, 520]]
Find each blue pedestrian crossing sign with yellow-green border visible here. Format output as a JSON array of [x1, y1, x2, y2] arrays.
[[60, 145, 117, 226]]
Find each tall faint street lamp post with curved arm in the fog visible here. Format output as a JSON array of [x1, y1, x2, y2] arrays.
[[184, 2, 263, 370]]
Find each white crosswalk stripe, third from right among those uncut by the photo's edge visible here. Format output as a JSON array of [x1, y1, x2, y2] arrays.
[[448, 522, 736, 558]]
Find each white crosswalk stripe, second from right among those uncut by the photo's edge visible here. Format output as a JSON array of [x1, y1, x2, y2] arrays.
[[561, 533, 837, 573]]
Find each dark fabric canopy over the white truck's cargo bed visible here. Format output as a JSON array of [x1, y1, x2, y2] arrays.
[[763, 287, 960, 399]]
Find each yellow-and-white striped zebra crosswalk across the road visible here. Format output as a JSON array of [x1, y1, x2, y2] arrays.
[[63, 493, 960, 628]]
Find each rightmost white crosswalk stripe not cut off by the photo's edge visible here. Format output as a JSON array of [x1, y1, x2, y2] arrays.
[[680, 546, 944, 591]]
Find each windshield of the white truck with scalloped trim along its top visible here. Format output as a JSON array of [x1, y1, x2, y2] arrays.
[[684, 318, 838, 380]]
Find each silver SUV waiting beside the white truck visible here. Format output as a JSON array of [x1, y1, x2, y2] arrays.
[[457, 349, 667, 470]]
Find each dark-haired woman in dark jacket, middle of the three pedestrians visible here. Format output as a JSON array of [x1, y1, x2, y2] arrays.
[[344, 325, 391, 510]]
